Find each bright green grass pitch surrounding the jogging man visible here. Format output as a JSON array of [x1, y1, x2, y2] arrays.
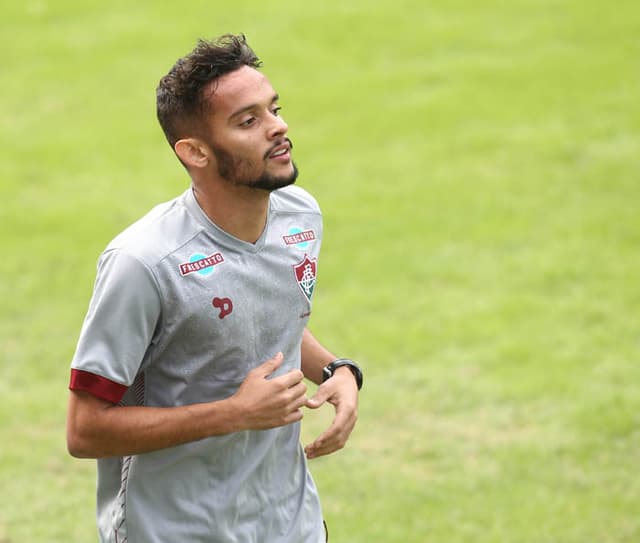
[[0, 0, 640, 543]]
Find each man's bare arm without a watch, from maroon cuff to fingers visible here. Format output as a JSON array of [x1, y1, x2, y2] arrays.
[[67, 353, 307, 458]]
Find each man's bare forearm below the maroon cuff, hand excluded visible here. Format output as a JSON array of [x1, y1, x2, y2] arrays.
[[67, 392, 240, 458]]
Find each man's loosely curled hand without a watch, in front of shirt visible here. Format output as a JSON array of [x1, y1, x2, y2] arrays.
[[229, 353, 307, 430]]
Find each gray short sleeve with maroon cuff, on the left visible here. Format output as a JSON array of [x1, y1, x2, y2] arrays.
[[69, 250, 162, 403]]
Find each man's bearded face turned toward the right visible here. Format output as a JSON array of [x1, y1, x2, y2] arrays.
[[206, 66, 298, 191]]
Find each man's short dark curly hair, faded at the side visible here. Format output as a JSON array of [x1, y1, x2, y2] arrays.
[[156, 34, 262, 147]]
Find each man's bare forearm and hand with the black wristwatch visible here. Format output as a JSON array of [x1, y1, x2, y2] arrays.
[[302, 329, 358, 458]]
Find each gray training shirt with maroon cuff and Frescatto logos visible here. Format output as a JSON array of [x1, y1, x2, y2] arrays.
[[70, 186, 324, 543]]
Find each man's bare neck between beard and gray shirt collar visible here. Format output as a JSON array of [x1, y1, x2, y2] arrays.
[[192, 182, 269, 243]]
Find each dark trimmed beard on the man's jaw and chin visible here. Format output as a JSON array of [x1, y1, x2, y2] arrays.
[[210, 138, 298, 192]]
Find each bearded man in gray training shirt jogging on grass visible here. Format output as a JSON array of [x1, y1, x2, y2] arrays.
[[67, 35, 362, 543]]
